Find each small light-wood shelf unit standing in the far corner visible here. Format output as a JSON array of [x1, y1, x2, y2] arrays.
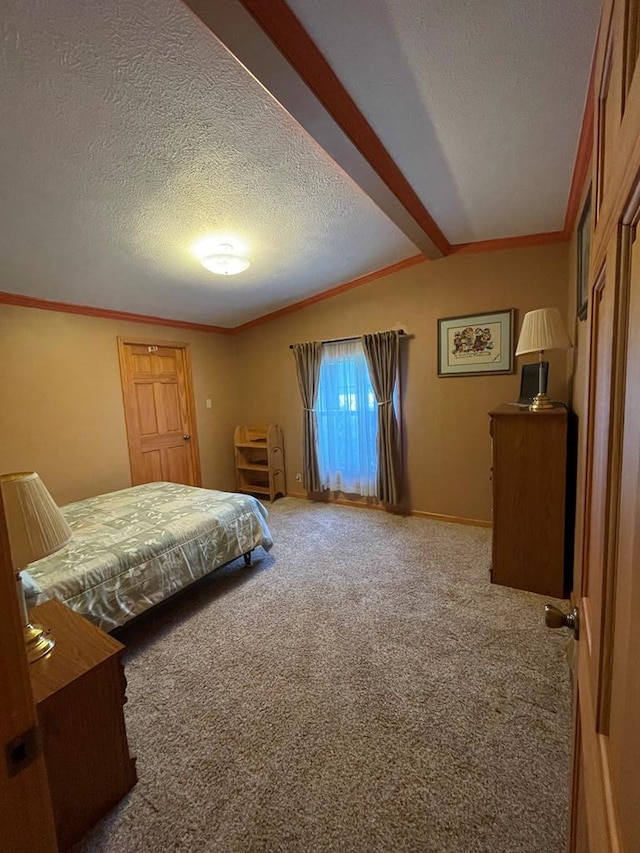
[[234, 424, 285, 501]]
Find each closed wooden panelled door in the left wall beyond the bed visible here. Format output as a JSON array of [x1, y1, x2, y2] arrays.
[[118, 339, 201, 486]]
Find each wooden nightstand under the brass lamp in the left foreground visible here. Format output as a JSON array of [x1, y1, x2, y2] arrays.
[[29, 600, 137, 850]]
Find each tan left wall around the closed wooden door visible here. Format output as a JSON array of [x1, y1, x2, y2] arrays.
[[0, 305, 237, 504]]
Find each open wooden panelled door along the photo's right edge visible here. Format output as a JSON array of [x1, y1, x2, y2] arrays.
[[570, 0, 640, 853]]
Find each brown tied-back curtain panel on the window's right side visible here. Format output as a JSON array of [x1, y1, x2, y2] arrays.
[[362, 332, 401, 506]]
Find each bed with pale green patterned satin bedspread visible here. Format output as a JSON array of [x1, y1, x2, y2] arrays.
[[22, 483, 273, 631]]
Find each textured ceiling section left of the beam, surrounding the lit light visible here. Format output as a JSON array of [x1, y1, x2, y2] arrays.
[[0, 0, 416, 326]]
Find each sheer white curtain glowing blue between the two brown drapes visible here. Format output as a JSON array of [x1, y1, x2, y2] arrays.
[[316, 338, 378, 497]]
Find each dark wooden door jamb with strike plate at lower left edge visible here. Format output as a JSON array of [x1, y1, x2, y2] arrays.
[[0, 496, 58, 853]]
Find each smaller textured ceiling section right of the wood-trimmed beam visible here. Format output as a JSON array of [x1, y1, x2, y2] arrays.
[[288, 0, 601, 243]]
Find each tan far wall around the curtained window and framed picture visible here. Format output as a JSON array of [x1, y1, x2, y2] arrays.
[[238, 244, 568, 520]]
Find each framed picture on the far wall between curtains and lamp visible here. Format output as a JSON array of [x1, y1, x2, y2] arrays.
[[438, 308, 515, 376]]
